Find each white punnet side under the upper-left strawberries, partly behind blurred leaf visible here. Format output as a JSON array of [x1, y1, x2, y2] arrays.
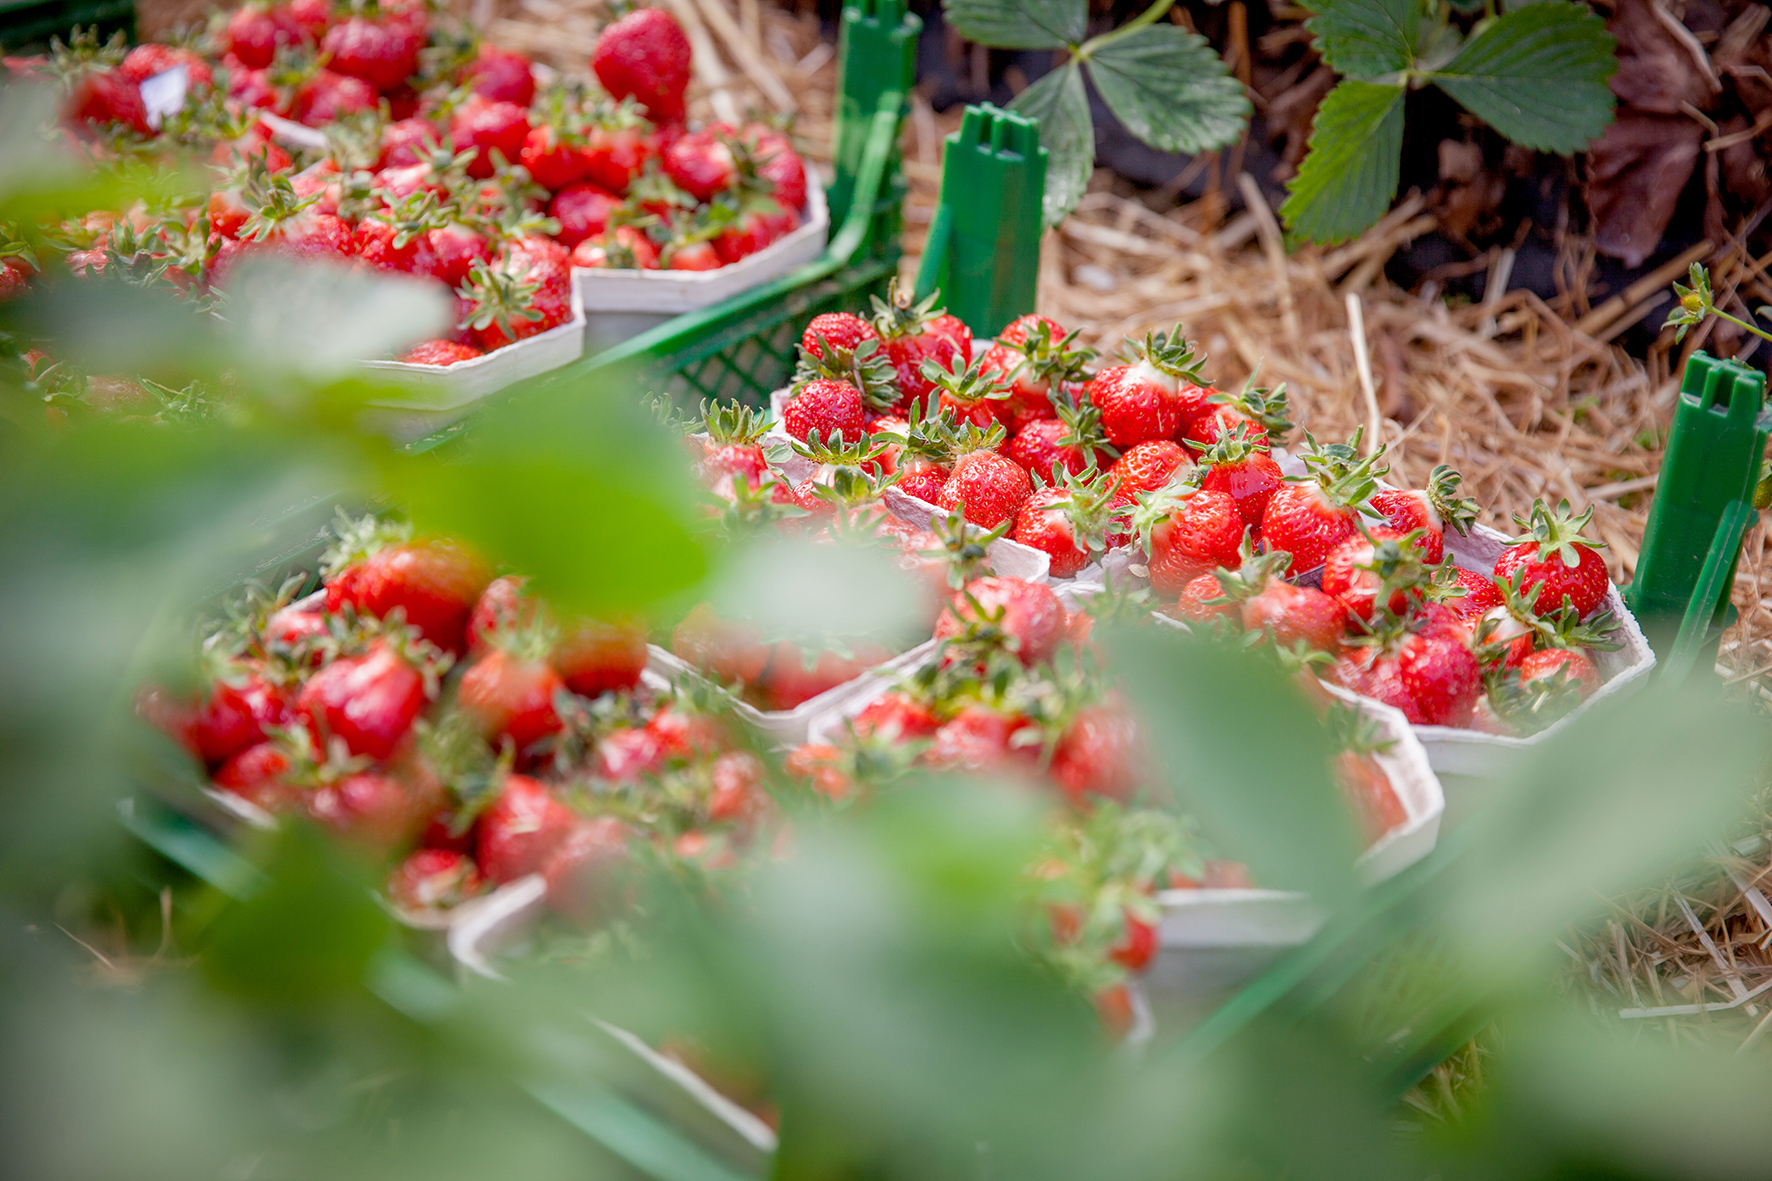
[[363, 280, 585, 442]]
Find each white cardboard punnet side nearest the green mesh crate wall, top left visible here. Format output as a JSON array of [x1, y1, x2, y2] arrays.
[[572, 167, 831, 353]]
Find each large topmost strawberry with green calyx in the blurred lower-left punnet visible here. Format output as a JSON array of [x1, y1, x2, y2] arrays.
[[324, 518, 491, 653]]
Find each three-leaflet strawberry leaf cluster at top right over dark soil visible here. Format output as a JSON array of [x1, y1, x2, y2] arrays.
[[1279, 0, 1618, 243]]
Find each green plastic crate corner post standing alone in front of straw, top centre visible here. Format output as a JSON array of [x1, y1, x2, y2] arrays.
[[916, 103, 1045, 337]]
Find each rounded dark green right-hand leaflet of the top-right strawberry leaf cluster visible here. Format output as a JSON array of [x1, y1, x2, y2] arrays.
[[1430, 0, 1618, 156]]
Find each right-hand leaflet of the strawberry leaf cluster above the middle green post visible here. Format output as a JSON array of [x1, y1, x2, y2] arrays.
[[1090, 25, 1249, 153]]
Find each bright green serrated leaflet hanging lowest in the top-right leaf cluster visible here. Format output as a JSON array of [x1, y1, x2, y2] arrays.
[[1279, 80, 1403, 243]]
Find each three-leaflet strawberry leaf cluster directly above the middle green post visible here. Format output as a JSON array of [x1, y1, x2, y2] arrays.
[[943, 0, 1249, 225]]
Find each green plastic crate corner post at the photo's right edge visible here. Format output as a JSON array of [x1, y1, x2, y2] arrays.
[[1625, 351, 1772, 667]]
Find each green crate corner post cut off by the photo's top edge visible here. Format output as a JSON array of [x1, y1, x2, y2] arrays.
[[826, 0, 923, 225]]
